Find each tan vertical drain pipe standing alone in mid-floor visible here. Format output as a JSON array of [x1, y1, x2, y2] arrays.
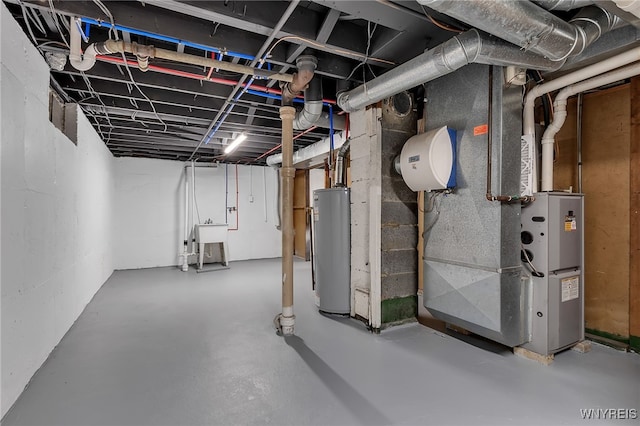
[[279, 106, 296, 336]]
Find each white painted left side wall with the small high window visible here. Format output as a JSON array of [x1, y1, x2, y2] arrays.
[[0, 4, 114, 415]]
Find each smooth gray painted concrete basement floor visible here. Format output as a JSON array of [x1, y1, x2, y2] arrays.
[[2, 259, 640, 426]]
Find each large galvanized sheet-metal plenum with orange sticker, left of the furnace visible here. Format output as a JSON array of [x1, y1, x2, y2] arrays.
[[424, 65, 529, 346]]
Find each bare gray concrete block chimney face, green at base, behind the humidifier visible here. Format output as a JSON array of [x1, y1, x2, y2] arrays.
[[380, 95, 418, 324]]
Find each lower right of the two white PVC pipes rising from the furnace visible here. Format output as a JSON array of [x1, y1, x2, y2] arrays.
[[542, 63, 640, 191]]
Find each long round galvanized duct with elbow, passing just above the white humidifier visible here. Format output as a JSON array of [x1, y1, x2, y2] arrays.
[[337, 30, 562, 112]]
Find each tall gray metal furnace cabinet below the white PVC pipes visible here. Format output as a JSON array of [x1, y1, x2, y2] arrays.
[[521, 192, 584, 355]]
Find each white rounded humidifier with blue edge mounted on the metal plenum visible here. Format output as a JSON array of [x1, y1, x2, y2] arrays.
[[395, 126, 456, 191]]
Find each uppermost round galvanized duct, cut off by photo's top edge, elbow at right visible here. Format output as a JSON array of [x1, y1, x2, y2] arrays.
[[418, 0, 619, 61]]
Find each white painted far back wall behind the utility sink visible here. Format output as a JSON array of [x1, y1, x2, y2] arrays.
[[115, 158, 282, 269]]
